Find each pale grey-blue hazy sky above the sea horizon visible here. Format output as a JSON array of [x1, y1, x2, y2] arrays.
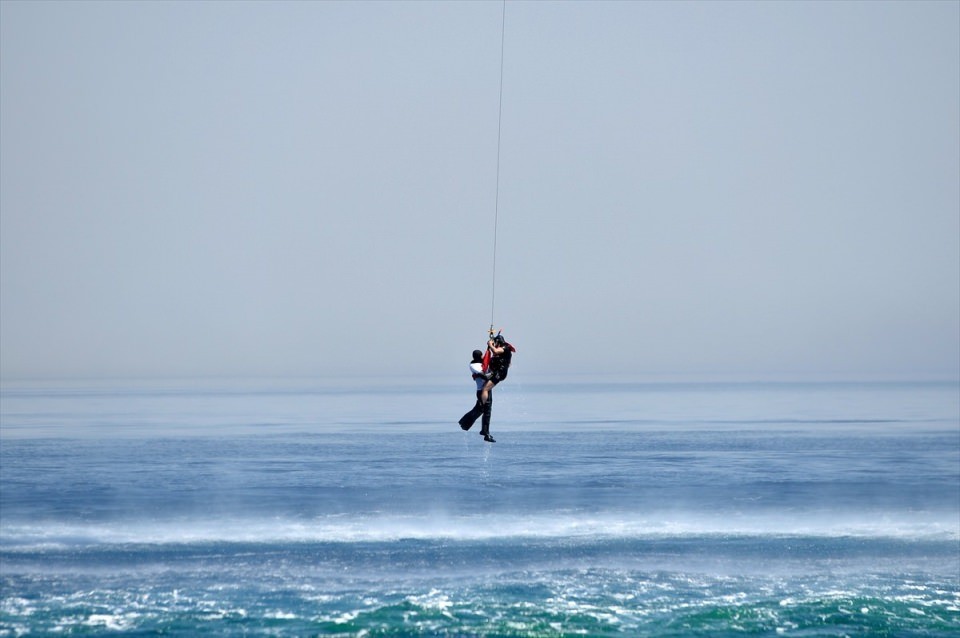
[[0, 0, 960, 380]]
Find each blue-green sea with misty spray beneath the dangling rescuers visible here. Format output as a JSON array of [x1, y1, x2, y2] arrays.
[[0, 374, 960, 636]]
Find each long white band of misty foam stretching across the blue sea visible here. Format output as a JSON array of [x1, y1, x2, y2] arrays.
[[0, 511, 960, 550]]
